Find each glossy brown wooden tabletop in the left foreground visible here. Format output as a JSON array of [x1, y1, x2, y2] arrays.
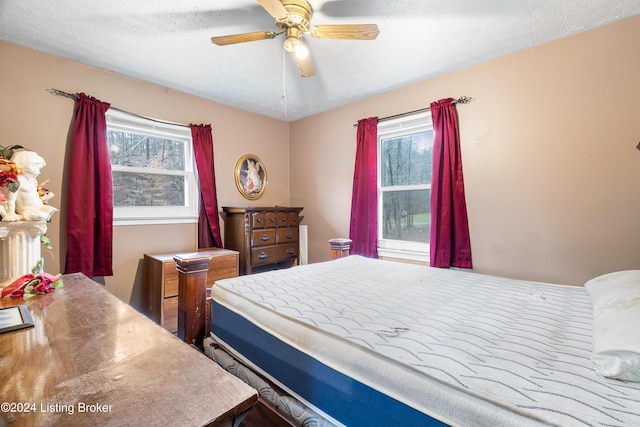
[[0, 274, 257, 426]]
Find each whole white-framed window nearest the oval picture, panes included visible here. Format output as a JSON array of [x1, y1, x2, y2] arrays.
[[107, 109, 198, 225]]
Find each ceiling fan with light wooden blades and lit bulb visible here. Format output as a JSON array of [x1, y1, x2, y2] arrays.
[[211, 0, 380, 77]]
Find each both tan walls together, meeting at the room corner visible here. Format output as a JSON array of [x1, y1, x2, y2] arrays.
[[0, 17, 640, 306]]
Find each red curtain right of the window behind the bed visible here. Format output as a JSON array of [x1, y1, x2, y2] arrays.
[[430, 98, 472, 268]]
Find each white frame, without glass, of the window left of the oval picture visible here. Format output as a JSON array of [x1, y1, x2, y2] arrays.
[[106, 109, 200, 226]]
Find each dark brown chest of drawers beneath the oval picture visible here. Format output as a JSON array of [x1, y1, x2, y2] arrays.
[[222, 206, 303, 274]]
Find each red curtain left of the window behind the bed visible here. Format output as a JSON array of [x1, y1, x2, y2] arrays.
[[349, 117, 378, 258]]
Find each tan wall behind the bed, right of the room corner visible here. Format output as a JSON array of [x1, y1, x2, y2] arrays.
[[290, 16, 640, 284]]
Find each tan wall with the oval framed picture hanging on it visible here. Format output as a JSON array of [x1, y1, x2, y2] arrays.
[[0, 41, 289, 307]]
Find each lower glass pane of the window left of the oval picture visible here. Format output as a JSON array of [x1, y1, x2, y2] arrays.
[[113, 171, 185, 206]]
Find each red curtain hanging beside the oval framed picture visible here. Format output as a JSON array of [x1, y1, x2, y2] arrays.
[[190, 124, 222, 248]]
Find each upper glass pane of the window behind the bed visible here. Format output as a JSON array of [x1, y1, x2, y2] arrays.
[[381, 131, 433, 187]]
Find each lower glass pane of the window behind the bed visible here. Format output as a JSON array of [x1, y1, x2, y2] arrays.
[[382, 190, 431, 243]]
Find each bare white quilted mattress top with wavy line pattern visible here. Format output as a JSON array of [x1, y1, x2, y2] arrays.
[[212, 256, 640, 426]]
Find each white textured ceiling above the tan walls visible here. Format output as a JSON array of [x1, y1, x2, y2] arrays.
[[0, 0, 640, 121]]
